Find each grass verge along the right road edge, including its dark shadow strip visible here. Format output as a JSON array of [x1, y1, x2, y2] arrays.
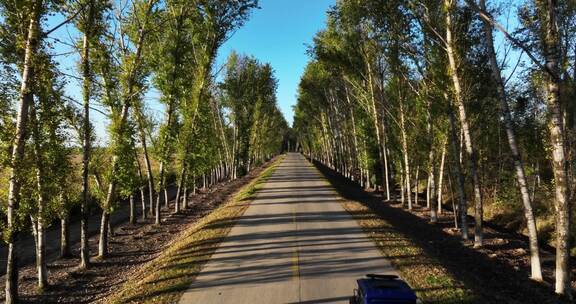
[[316, 164, 567, 304]]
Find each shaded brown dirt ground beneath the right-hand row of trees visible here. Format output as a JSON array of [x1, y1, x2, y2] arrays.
[[316, 160, 576, 304]]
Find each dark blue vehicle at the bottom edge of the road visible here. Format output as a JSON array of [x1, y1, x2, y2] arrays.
[[350, 274, 417, 304]]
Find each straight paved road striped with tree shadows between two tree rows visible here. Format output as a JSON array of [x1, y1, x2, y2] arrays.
[[180, 153, 395, 304]]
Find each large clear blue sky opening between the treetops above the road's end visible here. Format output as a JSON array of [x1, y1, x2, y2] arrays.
[[217, 0, 336, 125]]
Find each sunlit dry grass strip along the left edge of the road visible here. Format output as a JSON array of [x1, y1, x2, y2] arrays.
[[104, 159, 281, 303]]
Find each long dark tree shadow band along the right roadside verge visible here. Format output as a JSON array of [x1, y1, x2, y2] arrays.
[[315, 163, 563, 304]]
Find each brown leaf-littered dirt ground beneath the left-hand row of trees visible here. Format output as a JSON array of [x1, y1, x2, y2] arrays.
[[0, 163, 270, 303]]
